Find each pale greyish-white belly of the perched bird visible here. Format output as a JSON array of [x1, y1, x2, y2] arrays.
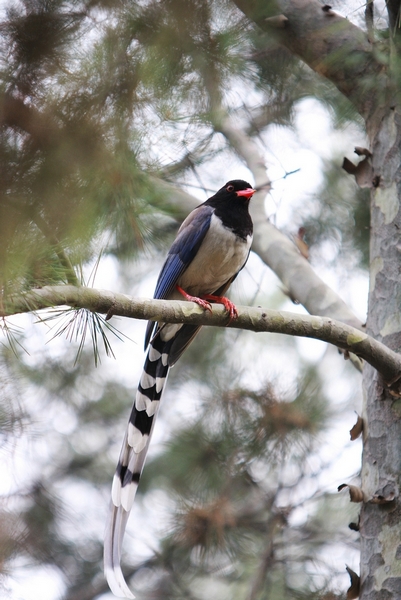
[[174, 215, 252, 299]]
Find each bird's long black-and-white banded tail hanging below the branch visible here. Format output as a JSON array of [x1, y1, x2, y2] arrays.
[[104, 331, 172, 598]]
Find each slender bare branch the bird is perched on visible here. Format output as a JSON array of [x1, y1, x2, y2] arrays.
[[2, 285, 401, 396]]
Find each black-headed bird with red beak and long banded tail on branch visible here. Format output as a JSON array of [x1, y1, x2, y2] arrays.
[[104, 179, 256, 598]]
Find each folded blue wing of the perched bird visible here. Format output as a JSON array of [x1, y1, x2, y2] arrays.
[[145, 204, 214, 349]]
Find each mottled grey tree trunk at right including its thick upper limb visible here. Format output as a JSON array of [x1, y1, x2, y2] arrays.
[[230, 0, 401, 600]]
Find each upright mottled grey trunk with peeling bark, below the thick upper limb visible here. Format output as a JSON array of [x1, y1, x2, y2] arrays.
[[360, 107, 401, 600]]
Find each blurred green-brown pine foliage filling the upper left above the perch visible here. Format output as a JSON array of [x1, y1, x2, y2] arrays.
[[0, 0, 368, 291]]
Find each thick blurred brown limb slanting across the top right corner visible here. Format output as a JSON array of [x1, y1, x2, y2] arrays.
[[234, 0, 389, 119]]
